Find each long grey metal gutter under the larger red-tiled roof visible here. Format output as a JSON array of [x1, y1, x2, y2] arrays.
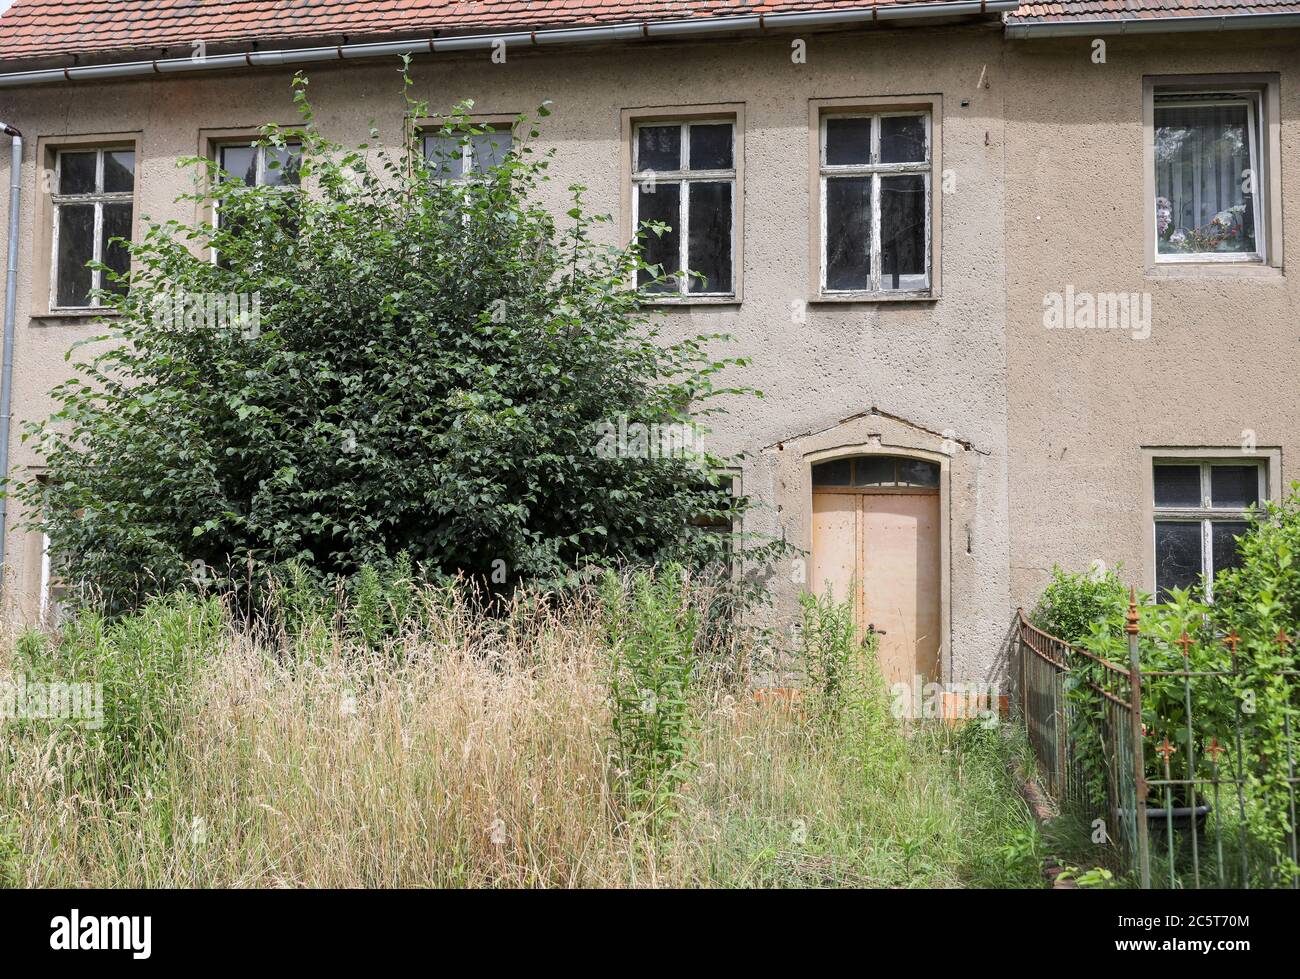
[[0, 0, 1021, 88]]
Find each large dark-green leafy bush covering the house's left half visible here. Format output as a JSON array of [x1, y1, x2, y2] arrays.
[[18, 77, 740, 608]]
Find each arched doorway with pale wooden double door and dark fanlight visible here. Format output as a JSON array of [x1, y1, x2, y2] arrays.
[[811, 455, 943, 685]]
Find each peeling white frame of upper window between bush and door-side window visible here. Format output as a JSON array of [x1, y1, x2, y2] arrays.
[[632, 116, 740, 303]]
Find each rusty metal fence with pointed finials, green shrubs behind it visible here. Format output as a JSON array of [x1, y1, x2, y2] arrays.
[[1013, 592, 1300, 888]]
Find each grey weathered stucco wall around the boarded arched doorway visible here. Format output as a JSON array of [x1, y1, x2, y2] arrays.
[[0, 29, 1010, 679]]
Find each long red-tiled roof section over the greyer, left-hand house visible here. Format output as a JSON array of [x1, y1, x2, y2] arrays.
[[0, 0, 977, 60]]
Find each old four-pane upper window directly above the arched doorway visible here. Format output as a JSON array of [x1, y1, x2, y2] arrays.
[[818, 111, 932, 295]]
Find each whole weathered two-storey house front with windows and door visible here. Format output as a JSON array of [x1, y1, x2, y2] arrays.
[[0, 0, 1300, 681]]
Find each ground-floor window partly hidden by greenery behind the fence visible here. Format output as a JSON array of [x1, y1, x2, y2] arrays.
[[1153, 459, 1268, 601]]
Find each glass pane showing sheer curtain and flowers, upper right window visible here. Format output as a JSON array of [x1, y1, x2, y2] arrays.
[[1156, 100, 1258, 255]]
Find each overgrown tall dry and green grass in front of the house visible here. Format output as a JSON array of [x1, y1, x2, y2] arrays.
[[0, 572, 1041, 887]]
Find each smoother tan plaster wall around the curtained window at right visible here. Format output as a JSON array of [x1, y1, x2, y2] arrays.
[[1006, 31, 1300, 605]]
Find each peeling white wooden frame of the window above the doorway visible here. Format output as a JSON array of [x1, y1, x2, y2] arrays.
[[818, 109, 935, 298]]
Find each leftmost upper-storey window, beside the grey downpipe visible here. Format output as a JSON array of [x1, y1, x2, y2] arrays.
[[49, 148, 135, 309]]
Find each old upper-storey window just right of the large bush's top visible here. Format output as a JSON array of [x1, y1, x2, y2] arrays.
[[631, 118, 738, 299]]
